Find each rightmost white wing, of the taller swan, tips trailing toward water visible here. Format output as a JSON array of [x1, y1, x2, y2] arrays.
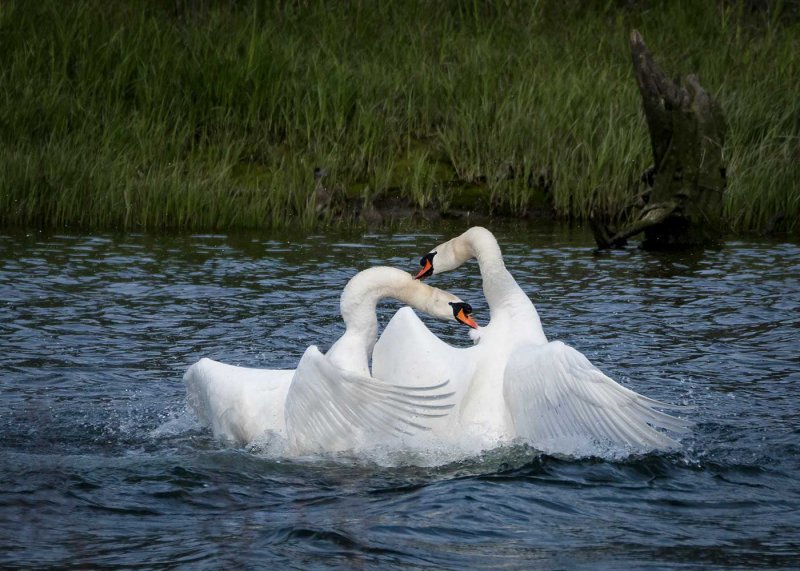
[[503, 341, 692, 454]]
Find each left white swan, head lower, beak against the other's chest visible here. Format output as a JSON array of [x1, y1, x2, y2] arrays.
[[184, 267, 477, 453]]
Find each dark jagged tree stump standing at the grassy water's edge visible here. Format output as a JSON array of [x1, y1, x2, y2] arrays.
[[590, 30, 727, 249]]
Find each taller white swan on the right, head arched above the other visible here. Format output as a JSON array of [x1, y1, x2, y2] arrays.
[[373, 227, 691, 454]]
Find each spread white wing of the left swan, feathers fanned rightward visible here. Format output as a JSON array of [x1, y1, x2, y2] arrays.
[[285, 346, 453, 452]]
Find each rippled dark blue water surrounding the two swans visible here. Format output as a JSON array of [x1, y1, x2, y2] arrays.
[[0, 227, 800, 569]]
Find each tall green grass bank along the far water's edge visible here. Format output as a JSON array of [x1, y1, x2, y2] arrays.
[[0, 0, 800, 231]]
